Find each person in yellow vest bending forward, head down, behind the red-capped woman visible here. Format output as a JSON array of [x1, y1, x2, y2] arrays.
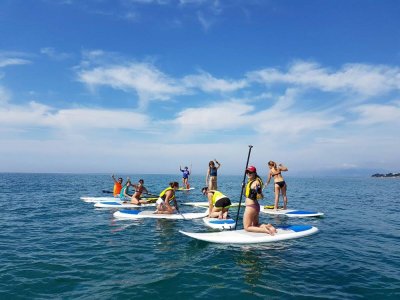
[[201, 187, 232, 219]]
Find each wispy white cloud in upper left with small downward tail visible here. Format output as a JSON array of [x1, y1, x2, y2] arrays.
[[78, 63, 186, 108]]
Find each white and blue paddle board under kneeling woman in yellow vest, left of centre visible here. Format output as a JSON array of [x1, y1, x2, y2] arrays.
[[114, 209, 208, 220]]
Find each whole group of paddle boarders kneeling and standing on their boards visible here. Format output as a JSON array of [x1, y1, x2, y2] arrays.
[[112, 159, 288, 235]]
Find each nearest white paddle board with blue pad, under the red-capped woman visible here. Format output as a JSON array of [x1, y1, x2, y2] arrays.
[[179, 225, 318, 244]]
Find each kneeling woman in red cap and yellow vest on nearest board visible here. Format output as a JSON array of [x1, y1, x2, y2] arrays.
[[243, 166, 276, 235]]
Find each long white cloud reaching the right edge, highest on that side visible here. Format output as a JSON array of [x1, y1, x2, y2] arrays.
[[247, 62, 400, 97]]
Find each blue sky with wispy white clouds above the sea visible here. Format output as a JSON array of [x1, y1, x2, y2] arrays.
[[0, 0, 400, 175]]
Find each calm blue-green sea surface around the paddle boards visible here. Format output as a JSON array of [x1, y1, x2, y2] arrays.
[[0, 173, 400, 299]]
